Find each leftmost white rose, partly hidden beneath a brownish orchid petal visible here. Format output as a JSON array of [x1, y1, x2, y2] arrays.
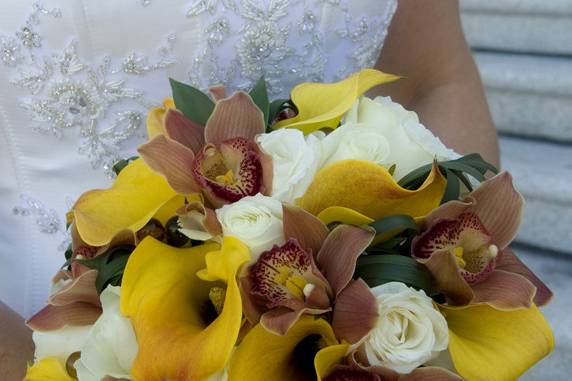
[[32, 325, 92, 363]]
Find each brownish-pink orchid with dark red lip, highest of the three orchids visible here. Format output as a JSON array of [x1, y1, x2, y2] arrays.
[[138, 88, 272, 207]]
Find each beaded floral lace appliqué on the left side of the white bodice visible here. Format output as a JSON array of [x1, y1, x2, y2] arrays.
[[0, 3, 175, 176]]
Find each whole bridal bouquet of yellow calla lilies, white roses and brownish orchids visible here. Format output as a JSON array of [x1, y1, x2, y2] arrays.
[[26, 70, 553, 381]]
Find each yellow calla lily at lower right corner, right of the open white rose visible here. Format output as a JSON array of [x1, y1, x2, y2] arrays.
[[440, 304, 554, 381]]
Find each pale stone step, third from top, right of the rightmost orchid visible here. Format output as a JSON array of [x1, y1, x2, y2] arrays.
[[500, 137, 572, 254]]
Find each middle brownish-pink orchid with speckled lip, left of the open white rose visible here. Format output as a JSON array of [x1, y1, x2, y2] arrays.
[[241, 205, 375, 337]]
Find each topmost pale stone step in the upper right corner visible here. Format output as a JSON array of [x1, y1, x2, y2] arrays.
[[460, 0, 572, 55]]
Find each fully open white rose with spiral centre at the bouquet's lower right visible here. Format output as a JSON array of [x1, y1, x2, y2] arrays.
[[364, 282, 449, 373]]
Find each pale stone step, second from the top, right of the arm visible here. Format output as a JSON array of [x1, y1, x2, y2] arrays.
[[474, 52, 572, 142]]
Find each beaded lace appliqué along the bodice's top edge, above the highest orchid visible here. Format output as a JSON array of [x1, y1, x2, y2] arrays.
[[187, 0, 397, 97]]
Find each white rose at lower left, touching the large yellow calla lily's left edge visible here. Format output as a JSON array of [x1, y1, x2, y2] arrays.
[[75, 286, 138, 381]]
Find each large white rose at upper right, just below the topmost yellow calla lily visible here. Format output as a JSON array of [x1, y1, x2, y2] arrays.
[[320, 97, 459, 180]]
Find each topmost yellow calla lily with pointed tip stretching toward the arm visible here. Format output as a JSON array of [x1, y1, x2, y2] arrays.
[[274, 69, 400, 134]]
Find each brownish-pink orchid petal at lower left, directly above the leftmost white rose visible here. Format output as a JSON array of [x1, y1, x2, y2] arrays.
[[26, 302, 101, 331]]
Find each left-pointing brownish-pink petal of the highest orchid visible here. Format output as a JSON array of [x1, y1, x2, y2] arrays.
[[137, 135, 200, 194]]
